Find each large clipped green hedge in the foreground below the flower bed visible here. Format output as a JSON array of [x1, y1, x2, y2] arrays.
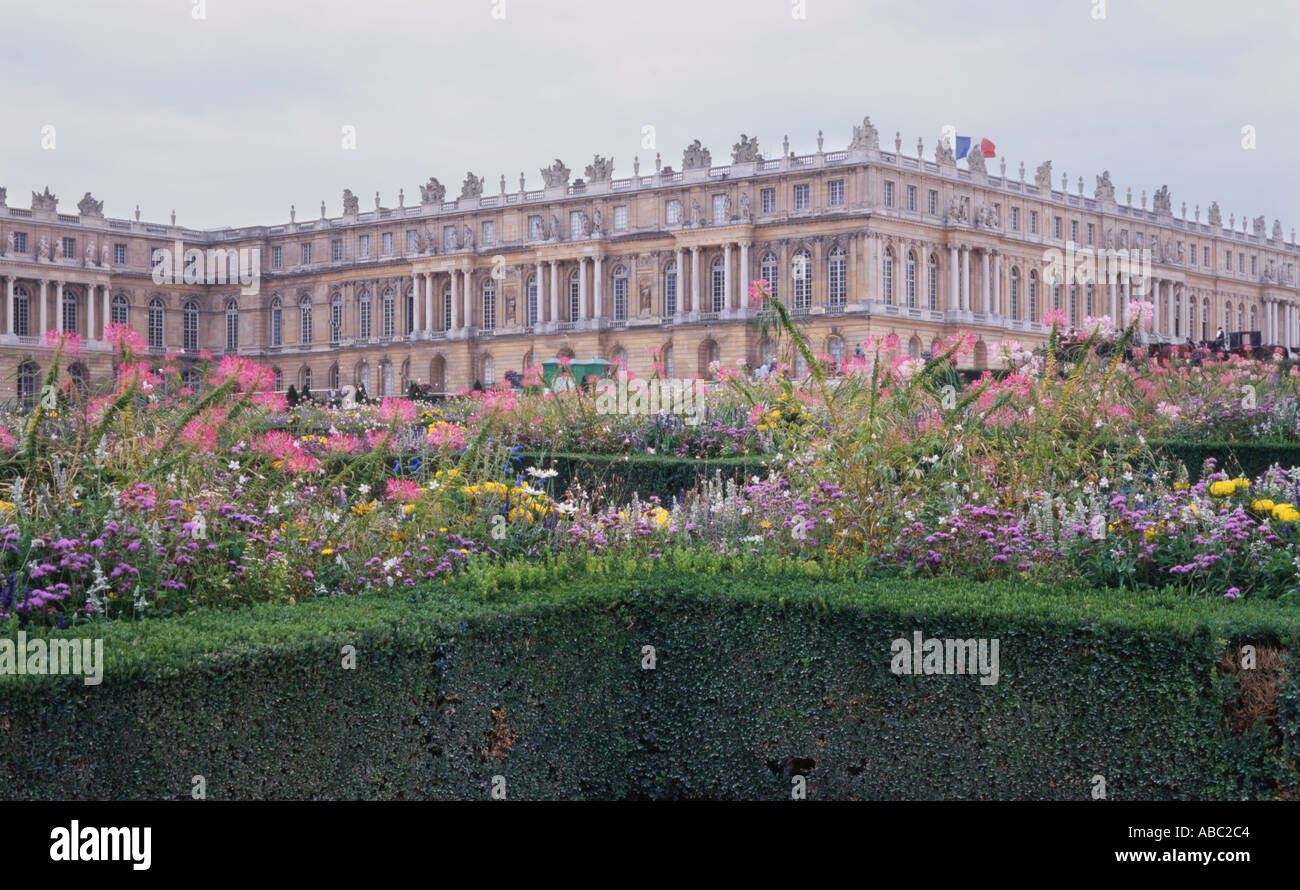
[[0, 556, 1300, 799]]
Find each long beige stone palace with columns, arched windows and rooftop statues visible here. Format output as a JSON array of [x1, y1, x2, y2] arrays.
[[0, 120, 1300, 400]]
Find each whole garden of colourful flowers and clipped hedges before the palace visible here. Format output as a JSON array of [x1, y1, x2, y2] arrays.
[[0, 281, 1300, 799]]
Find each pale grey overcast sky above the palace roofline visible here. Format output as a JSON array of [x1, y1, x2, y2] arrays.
[[0, 0, 1300, 235]]
